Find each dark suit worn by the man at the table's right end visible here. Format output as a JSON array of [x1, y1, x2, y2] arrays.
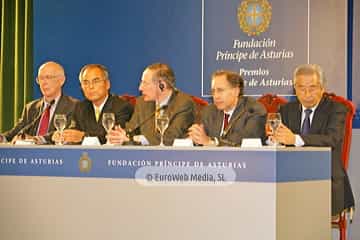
[[280, 97, 354, 215]]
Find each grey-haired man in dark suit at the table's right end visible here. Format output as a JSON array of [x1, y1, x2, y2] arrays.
[[273, 64, 354, 216]]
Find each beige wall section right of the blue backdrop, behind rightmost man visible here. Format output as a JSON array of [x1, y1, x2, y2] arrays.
[[309, 0, 347, 97]]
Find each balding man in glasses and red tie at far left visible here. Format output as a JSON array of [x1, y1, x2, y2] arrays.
[[0, 62, 77, 144]]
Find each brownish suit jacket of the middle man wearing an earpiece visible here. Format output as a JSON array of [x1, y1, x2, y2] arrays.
[[126, 91, 195, 145]]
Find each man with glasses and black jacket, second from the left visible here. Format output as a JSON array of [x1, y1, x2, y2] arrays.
[[54, 64, 133, 143]]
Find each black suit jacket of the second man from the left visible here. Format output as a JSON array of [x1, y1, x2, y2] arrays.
[[71, 95, 133, 144]]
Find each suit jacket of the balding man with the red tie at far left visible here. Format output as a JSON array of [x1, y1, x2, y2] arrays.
[[3, 95, 78, 143]]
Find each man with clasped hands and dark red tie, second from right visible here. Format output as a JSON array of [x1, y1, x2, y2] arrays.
[[189, 70, 266, 146]]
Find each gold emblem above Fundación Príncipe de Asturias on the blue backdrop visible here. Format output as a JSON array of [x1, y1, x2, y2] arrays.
[[238, 0, 272, 36]]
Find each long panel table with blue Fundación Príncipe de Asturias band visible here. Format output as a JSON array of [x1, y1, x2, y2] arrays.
[[0, 145, 331, 240]]
